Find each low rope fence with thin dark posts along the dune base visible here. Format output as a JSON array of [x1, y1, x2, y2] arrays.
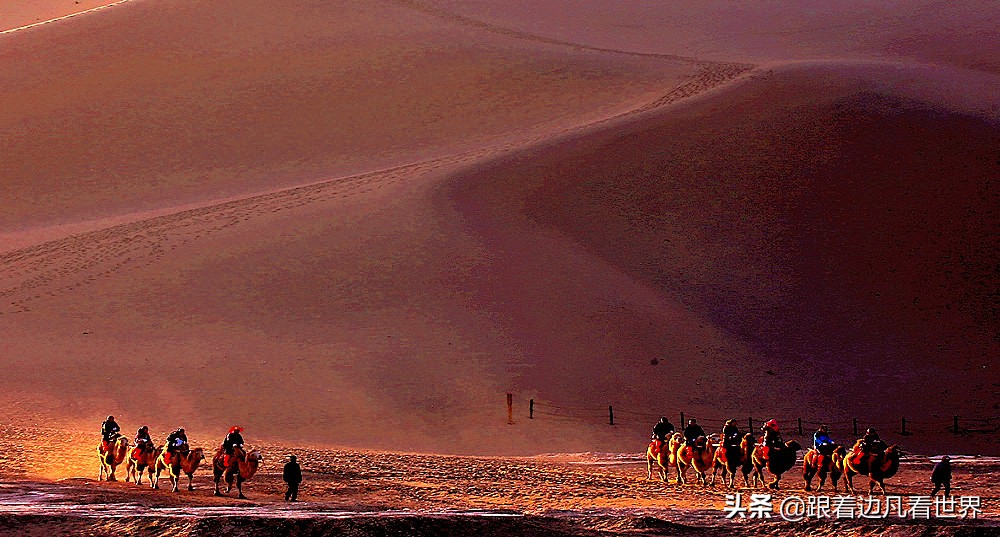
[[507, 394, 1000, 436]]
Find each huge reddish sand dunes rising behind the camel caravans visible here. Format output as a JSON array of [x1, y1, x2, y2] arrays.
[[0, 0, 1000, 531]]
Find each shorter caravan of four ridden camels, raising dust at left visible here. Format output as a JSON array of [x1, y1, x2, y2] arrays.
[[97, 416, 264, 499]]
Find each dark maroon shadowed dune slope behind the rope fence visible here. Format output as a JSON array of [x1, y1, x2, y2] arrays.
[[451, 61, 1000, 443]]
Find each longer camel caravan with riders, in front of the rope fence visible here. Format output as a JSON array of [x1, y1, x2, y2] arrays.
[[646, 418, 902, 495]]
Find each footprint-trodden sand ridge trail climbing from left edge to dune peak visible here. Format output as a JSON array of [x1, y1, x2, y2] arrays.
[[0, 62, 753, 315]]
